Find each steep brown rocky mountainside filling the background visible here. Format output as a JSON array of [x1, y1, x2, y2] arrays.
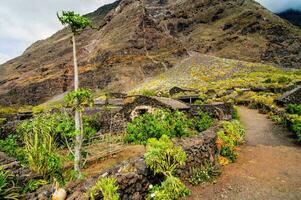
[[0, 0, 301, 105]]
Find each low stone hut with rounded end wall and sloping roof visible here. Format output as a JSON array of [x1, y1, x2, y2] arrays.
[[120, 95, 190, 121]]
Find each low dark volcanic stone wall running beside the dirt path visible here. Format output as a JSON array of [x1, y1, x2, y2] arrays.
[[63, 127, 219, 200]]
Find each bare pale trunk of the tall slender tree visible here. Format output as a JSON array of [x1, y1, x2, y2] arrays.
[[72, 34, 82, 179]]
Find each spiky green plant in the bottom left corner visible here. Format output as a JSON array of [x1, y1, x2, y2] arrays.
[[0, 168, 20, 200]]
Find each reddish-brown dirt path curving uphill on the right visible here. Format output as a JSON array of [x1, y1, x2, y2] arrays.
[[187, 107, 301, 200]]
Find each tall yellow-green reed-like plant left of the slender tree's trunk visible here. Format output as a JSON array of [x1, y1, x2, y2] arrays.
[[17, 114, 62, 179]]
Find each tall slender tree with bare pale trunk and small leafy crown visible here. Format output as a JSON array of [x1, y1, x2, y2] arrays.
[[57, 11, 91, 178]]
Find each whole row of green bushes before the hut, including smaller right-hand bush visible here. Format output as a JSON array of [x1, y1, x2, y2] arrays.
[[125, 110, 214, 144]]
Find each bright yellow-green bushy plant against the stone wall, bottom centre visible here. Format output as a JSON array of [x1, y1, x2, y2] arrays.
[[144, 135, 190, 200]]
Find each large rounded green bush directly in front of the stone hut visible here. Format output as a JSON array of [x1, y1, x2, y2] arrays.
[[125, 110, 191, 144]]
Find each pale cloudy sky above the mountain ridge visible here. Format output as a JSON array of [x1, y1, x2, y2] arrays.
[[0, 0, 301, 64]]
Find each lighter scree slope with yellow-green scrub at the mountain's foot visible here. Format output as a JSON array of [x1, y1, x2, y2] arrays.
[[130, 52, 301, 94]]
